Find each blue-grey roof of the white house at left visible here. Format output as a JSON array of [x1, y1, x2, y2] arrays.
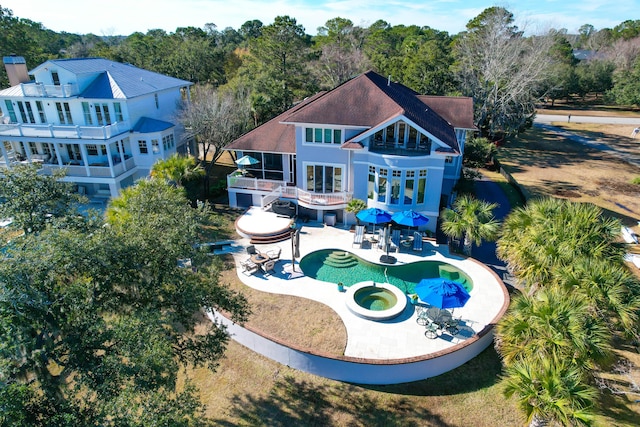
[[30, 58, 192, 98]]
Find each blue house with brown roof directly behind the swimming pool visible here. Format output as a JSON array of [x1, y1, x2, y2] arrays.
[[225, 71, 477, 230]]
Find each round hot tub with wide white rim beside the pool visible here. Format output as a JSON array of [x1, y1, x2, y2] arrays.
[[345, 281, 407, 320]]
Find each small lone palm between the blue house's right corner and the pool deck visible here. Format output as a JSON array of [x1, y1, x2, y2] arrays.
[[442, 195, 500, 255]]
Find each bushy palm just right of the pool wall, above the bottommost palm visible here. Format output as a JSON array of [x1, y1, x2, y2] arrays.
[[496, 286, 612, 373]]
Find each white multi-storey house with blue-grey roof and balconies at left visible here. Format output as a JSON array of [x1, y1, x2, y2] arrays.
[[0, 56, 192, 197]]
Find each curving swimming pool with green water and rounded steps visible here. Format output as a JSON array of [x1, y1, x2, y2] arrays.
[[300, 249, 473, 294]]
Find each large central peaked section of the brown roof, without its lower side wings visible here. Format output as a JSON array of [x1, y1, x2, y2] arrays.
[[284, 71, 460, 151]]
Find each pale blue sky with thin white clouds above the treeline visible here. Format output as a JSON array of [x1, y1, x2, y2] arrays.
[[5, 0, 640, 35]]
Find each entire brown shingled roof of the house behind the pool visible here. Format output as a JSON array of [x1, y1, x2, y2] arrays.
[[226, 71, 475, 153]]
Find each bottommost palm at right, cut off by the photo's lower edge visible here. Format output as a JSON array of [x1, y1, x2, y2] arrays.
[[503, 359, 598, 426]]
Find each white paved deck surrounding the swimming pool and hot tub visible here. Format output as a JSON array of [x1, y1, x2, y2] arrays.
[[227, 212, 508, 360]]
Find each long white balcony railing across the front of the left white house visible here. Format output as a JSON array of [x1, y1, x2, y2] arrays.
[[0, 121, 131, 140]]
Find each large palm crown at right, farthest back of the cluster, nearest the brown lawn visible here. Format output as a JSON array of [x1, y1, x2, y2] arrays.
[[497, 198, 623, 292]]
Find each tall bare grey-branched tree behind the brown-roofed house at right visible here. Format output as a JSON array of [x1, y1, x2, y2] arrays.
[[455, 7, 553, 137]]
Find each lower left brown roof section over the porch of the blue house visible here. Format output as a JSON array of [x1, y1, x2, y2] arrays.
[[225, 92, 324, 154]]
